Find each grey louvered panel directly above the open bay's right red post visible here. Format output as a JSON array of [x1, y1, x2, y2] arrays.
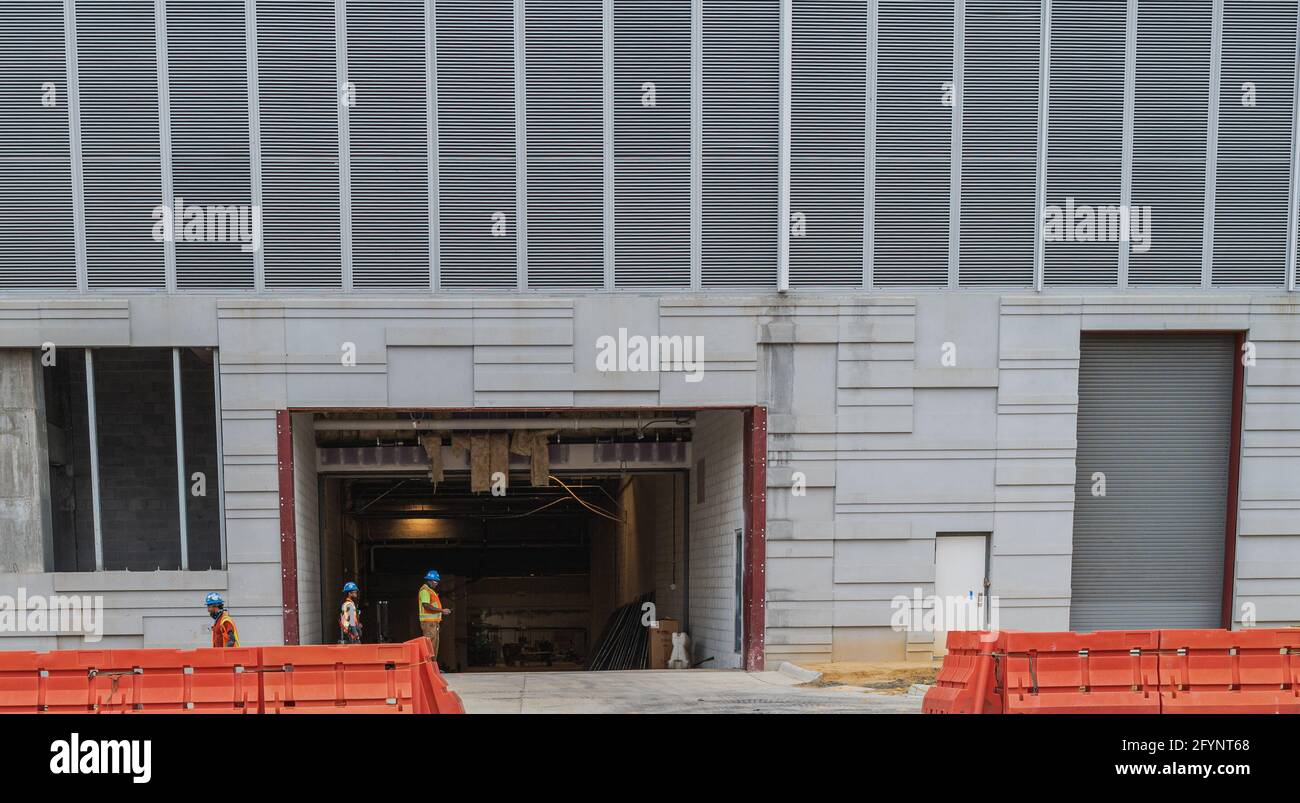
[[702, 0, 781, 287]]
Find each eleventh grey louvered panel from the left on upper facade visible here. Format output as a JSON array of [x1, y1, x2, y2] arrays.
[[871, 0, 954, 287]]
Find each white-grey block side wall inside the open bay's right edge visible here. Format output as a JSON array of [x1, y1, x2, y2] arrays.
[[689, 411, 745, 669]]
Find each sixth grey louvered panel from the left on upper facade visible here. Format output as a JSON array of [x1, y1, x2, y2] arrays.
[[436, 0, 517, 288]]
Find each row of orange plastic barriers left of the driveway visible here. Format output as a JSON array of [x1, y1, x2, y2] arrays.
[[0, 638, 464, 713]]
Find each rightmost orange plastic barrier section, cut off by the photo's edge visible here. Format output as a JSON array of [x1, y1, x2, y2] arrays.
[[1160, 629, 1300, 713]]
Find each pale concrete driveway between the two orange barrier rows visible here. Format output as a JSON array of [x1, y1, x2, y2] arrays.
[[443, 669, 920, 713]]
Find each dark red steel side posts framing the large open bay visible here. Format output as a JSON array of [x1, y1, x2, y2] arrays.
[[276, 407, 767, 652]]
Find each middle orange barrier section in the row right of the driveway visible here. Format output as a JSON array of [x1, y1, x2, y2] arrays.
[[1002, 630, 1160, 713]]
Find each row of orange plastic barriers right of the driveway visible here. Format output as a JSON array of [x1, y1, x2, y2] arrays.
[[922, 629, 1300, 713]]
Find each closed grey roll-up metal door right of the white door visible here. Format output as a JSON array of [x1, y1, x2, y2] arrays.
[[1070, 334, 1235, 630]]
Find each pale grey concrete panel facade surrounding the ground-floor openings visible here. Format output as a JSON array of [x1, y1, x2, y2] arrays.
[[0, 290, 1300, 661]]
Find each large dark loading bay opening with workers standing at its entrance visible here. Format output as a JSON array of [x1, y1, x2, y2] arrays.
[[280, 409, 766, 670]]
